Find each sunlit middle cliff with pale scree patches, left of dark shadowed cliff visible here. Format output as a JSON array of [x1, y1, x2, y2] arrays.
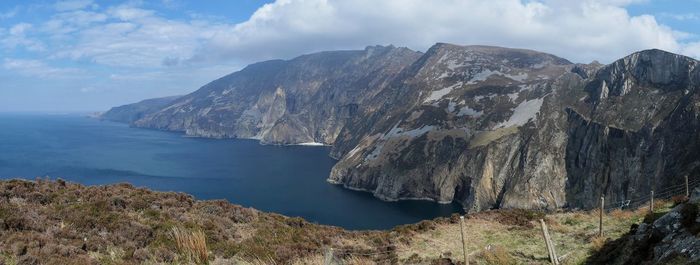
[[329, 44, 583, 211]]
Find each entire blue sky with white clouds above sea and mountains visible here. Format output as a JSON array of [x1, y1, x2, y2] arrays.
[[0, 0, 700, 113]]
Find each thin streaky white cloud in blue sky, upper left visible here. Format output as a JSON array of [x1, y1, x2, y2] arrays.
[[51, 5, 218, 67]]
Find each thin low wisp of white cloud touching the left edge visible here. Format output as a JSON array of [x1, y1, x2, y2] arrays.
[[2, 58, 83, 79]]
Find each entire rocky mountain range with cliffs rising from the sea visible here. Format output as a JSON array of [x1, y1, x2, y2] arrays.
[[108, 43, 700, 211]]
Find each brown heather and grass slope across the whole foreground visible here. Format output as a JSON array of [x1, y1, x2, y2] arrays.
[[0, 180, 667, 264]]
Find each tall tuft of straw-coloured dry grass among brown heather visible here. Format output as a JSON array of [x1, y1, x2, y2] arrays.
[[171, 227, 209, 264]]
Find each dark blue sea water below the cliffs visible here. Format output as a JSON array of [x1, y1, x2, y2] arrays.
[[0, 114, 460, 229]]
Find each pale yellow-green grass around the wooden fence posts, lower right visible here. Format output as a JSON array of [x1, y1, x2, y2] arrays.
[[398, 201, 673, 264]]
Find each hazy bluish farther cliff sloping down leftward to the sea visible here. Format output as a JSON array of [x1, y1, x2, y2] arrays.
[[129, 46, 420, 144]]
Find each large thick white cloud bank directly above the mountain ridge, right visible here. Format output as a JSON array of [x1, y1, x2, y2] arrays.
[[190, 0, 681, 62]]
